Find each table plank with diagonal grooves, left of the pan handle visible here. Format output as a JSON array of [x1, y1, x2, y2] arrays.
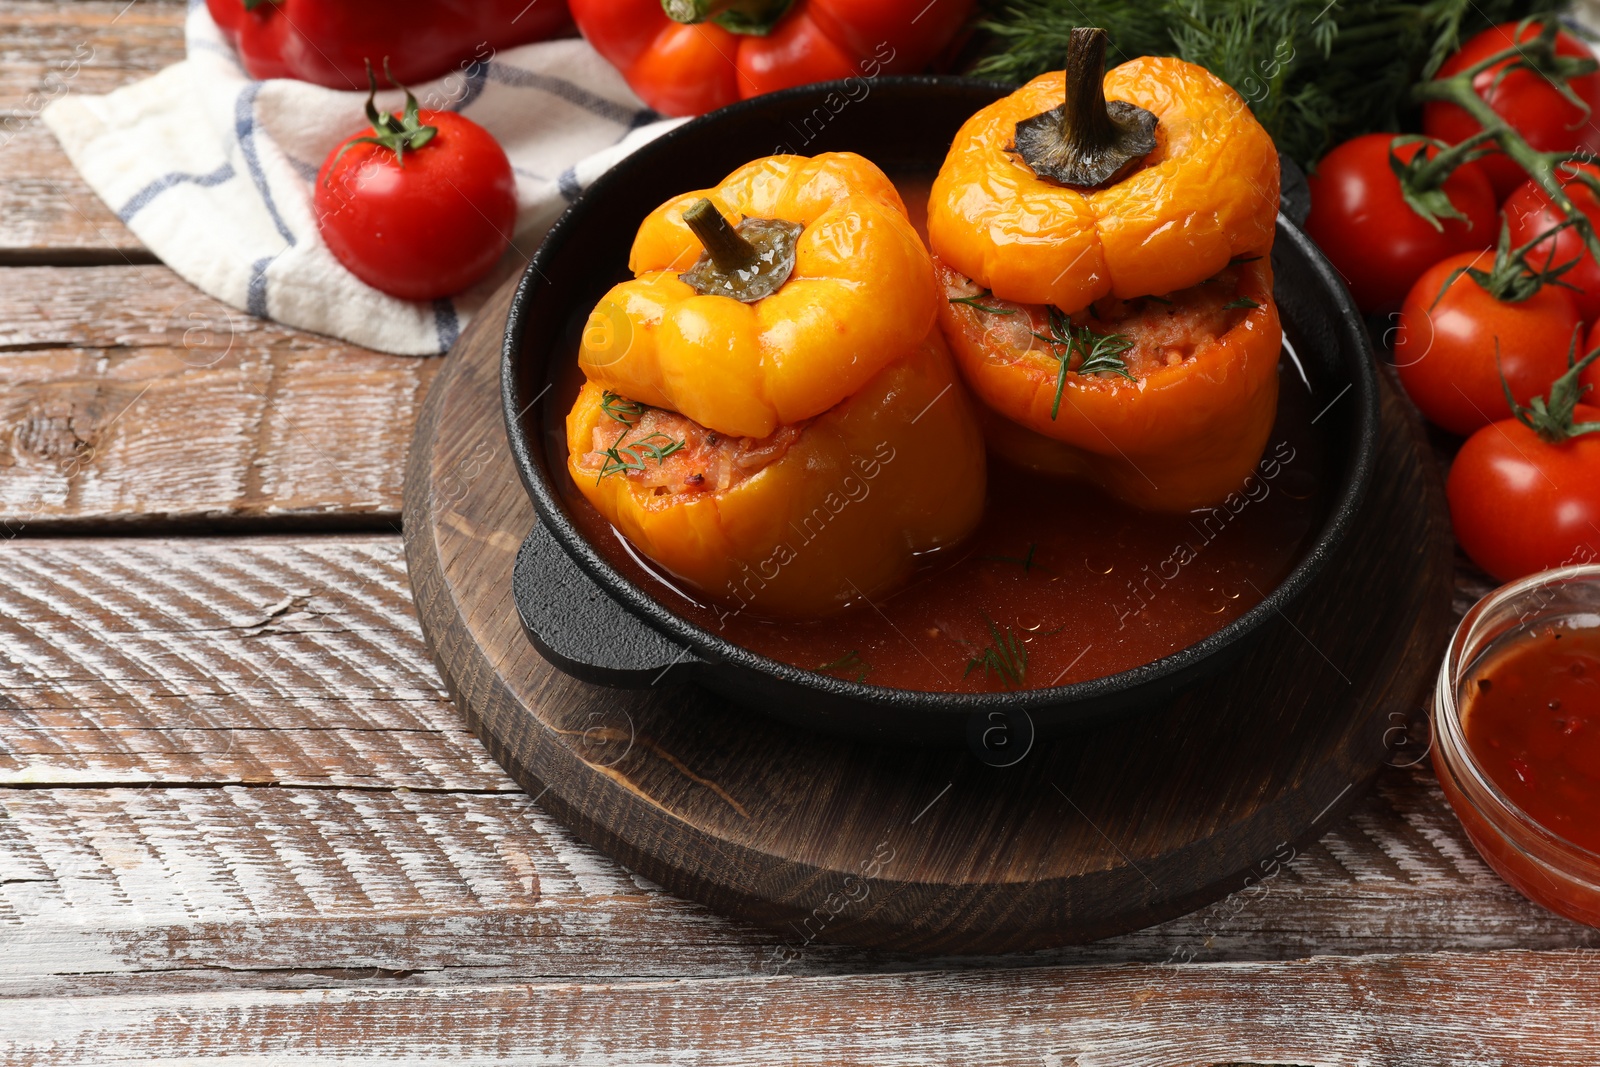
[[0, 537, 486, 790]]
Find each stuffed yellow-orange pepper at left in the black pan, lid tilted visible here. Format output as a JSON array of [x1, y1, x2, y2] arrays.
[[566, 154, 984, 616]]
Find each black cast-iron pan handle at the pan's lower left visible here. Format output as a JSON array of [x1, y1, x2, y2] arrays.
[[512, 523, 704, 689]]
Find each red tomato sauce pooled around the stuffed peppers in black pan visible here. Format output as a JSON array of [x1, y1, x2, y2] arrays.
[[566, 178, 1330, 693]]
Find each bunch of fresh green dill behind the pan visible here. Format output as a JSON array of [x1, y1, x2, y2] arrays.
[[973, 0, 1563, 165]]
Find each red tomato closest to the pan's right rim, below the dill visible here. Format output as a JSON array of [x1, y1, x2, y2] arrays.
[[1306, 133, 1499, 314]]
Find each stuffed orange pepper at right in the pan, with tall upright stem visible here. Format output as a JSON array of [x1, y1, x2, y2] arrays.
[[928, 29, 1282, 510]]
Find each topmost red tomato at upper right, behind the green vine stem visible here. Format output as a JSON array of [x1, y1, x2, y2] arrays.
[[1422, 22, 1600, 198]]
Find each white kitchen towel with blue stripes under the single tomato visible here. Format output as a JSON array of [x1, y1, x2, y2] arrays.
[[43, 0, 678, 355]]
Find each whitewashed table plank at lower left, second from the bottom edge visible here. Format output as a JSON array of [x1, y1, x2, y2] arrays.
[[0, 787, 796, 991]]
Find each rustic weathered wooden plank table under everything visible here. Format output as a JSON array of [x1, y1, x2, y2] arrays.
[[0, 0, 1600, 1067]]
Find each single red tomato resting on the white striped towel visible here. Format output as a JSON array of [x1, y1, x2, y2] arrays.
[[315, 108, 517, 301]]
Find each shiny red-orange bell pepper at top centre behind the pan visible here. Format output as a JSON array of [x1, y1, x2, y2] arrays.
[[570, 0, 973, 115]]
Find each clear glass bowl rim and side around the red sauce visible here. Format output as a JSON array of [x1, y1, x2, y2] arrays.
[[1434, 565, 1600, 926]]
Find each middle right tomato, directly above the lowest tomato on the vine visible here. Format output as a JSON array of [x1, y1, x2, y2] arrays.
[[1395, 253, 1582, 435]]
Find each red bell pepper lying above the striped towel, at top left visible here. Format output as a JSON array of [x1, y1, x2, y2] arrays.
[[206, 0, 570, 93]]
